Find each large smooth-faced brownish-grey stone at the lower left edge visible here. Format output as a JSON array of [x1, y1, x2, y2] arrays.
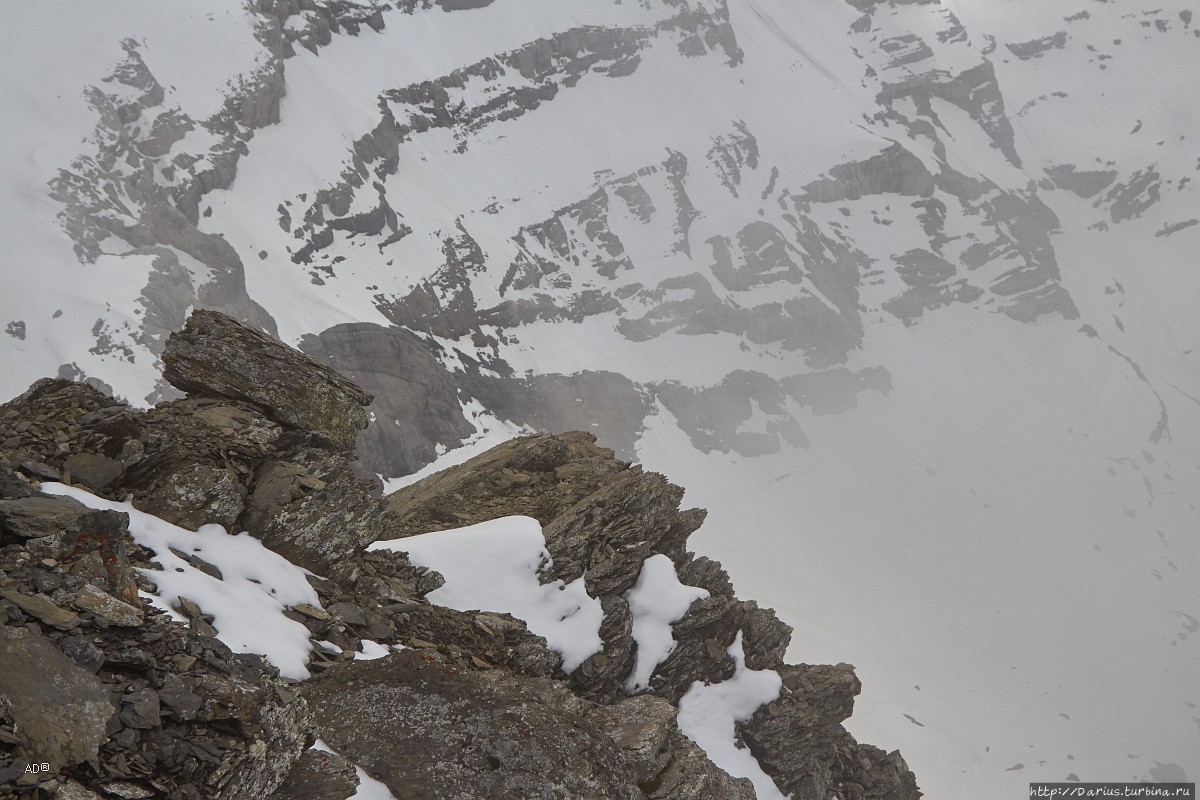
[[0, 624, 116, 772]]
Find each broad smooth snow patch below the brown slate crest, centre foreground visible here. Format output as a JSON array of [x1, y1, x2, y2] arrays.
[[367, 517, 604, 673]]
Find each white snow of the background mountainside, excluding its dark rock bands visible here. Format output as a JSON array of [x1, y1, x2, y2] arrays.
[[7, 0, 1200, 800]]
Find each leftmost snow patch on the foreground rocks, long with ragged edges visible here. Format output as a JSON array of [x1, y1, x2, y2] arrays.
[[42, 482, 320, 680]]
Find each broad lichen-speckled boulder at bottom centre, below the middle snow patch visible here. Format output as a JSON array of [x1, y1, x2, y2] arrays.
[[302, 651, 642, 800]]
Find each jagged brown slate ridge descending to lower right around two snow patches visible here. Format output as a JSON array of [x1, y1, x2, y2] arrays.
[[386, 433, 920, 800]]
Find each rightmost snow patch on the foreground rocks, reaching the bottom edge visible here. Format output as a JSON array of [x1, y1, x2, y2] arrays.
[[679, 631, 786, 800]]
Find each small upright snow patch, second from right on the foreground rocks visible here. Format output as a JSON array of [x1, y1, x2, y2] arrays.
[[625, 553, 708, 693]]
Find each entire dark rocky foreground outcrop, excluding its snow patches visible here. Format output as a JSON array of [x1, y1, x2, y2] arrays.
[[0, 312, 919, 800]]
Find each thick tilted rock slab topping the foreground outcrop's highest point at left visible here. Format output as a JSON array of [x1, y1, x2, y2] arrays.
[[162, 311, 372, 447]]
